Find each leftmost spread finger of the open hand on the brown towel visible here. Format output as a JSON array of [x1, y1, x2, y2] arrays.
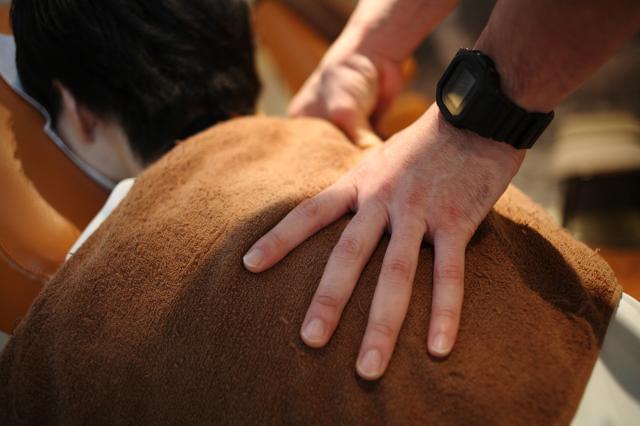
[[242, 178, 356, 272]]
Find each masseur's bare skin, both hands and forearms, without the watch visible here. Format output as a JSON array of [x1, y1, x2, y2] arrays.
[[244, 0, 640, 380]]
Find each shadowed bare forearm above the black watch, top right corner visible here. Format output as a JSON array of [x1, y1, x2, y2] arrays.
[[475, 0, 640, 111]]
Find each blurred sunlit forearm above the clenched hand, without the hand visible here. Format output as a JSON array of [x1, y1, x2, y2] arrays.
[[336, 0, 458, 62]]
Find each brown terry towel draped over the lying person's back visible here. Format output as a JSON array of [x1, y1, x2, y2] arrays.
[[0, 118, 621, 425]]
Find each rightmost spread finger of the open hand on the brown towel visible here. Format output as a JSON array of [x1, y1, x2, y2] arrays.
[[428, 236, 466, 357]]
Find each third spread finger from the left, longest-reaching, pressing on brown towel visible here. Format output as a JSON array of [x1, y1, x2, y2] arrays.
[[356, 218, 426, 380]]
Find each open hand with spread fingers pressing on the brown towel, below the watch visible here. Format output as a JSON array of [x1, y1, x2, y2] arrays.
[[244, 106, 524, 380]]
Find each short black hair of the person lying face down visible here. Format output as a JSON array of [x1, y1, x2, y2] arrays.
[[11, 0, 260, 163]]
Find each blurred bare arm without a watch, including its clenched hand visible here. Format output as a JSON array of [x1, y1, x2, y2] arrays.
[[289, 0, 458, 142]]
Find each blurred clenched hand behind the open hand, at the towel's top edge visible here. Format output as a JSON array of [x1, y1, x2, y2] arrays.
[[289, 43, 403, 144]]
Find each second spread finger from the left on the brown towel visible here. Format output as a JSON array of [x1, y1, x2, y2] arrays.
[[300, 205, 387, 348]]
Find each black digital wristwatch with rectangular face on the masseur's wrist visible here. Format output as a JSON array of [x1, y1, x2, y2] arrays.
[[436, 49, 553, 149]]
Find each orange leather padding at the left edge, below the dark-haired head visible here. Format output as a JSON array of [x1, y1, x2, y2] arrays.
[[0, 6, 108, 332]]
